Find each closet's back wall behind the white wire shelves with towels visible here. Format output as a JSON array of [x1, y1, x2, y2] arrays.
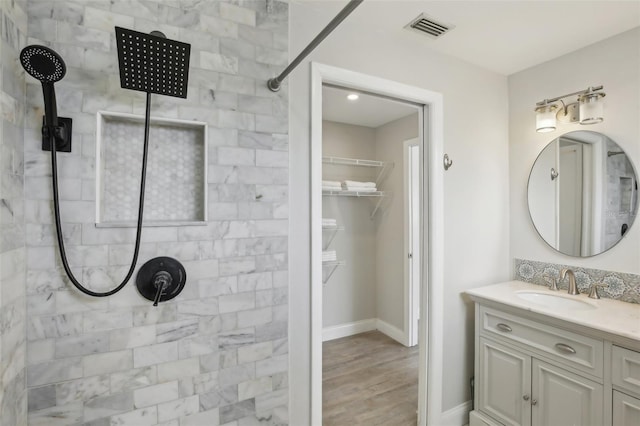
[[322, 121, 376, 327]]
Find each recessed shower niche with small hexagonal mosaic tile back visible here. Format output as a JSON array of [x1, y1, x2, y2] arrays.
[[96, 112, 207, 227]]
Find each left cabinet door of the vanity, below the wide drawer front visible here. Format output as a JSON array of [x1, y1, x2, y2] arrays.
[[476, 338, 531, 425]]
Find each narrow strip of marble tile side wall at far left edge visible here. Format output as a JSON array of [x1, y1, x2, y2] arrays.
[[0, 0, 27, 426]]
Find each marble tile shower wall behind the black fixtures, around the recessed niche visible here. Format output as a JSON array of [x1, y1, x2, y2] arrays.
[[24, 0, 289, 426]]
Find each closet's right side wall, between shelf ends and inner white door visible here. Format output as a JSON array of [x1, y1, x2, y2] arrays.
[[376, 113, 418, 330]]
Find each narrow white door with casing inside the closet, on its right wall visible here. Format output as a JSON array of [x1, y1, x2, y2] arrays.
[[404, 139, 421, 346]]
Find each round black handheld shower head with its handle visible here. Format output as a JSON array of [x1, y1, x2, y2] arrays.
[[20, 44, 67, 129]]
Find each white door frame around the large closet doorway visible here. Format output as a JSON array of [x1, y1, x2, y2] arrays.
[[310, 62, 444, 426]]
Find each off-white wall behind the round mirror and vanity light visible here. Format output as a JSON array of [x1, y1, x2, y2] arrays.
[[509, 28, 640, 274]]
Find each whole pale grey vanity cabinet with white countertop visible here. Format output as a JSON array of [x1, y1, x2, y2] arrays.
[[466, 281, 640, 426]]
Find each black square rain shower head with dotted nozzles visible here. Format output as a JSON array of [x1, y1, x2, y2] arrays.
[[116, 27, 191, 98]]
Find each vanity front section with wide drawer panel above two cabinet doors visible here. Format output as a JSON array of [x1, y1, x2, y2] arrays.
[[476, 308, 603, 426]]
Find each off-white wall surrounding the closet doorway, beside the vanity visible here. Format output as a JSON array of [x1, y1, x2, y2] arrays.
[[288, 2, 509, 424]]
